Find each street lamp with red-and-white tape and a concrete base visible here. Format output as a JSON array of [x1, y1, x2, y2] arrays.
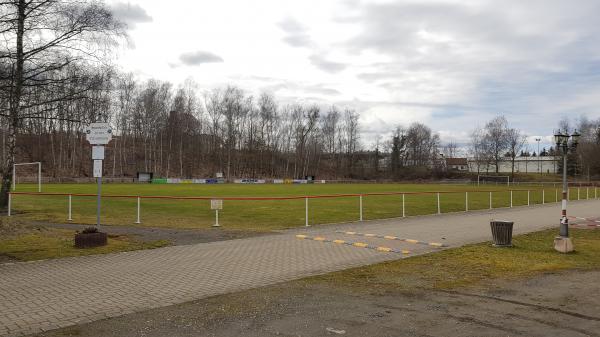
[[554, 130, 581, 253]]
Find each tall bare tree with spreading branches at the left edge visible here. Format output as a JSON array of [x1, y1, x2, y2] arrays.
[[0, 0, 123, 206]]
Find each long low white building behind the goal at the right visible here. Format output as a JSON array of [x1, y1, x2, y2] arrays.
[[468, 156, 562, 174]]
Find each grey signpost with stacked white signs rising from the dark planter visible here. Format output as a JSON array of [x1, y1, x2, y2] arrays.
[[85, 123, 112, 229]]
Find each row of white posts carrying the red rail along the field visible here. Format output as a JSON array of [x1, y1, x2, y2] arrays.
[[8, 187, 598, 223]]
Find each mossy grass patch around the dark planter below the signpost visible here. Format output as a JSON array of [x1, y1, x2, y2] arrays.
[[0, 218, 170, 261]]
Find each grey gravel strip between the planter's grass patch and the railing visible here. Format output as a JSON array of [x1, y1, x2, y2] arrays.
[[38, 223, 269, 245]]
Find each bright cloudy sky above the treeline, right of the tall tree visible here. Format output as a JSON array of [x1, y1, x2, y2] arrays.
[[107, 0, 600, 150]]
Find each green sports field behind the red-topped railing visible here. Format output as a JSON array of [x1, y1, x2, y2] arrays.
[[12, 184, 596, 231]]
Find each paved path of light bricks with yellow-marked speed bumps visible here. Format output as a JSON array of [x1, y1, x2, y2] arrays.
[[0, 200, 600, 336]]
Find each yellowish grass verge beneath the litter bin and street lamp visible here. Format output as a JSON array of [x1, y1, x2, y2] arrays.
[[308, 229, 600, 292]]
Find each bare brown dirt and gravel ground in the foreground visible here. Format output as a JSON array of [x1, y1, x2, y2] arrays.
[[30, 271, 600, 337]]
